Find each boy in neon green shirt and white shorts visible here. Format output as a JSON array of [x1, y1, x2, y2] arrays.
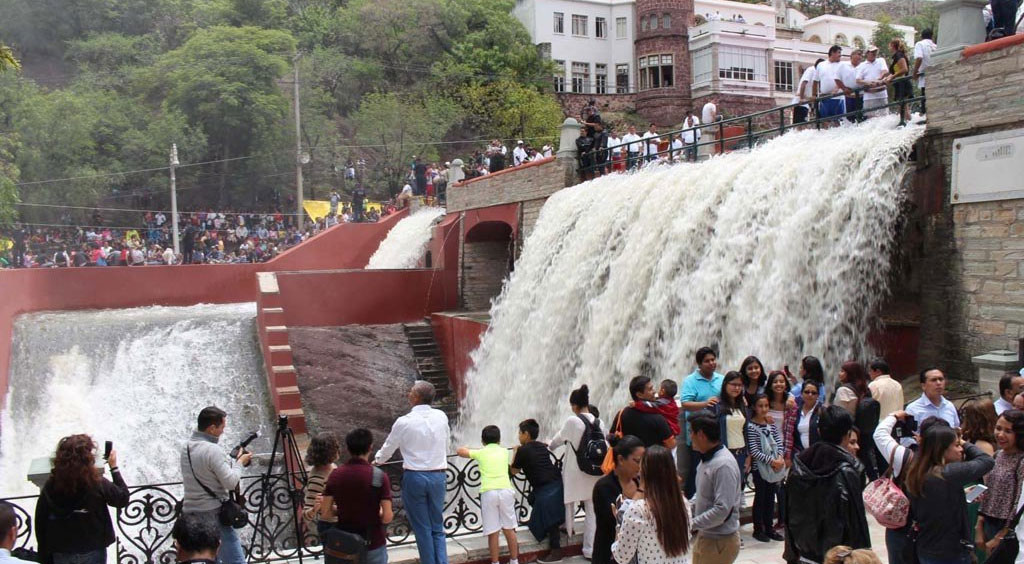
[[457, 425, 519, 564]]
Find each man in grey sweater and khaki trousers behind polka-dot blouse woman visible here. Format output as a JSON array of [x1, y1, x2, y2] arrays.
[[689, 411, 742, 564]]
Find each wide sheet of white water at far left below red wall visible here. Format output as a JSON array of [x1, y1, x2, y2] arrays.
[[0, 303, 273, 496]]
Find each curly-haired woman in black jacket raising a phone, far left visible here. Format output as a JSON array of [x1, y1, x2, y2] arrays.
[[36, 435, 128, 564]]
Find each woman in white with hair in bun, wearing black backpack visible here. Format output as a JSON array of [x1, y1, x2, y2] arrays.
[[548, 384, 601, 559]]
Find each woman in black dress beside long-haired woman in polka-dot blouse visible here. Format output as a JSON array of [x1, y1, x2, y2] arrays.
[[591, 435, 644, 564]]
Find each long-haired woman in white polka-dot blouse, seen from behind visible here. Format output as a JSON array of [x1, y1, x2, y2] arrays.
[[611, 445, 690, 564]]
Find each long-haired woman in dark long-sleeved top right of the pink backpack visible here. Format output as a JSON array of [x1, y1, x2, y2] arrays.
[[903, 425, 995, 564]]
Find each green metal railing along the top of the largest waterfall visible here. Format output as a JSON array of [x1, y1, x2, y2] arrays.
[[578, 73, 925, 173]]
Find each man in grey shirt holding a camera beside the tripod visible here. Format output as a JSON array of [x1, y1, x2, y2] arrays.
[[181, 405, 252, 564]]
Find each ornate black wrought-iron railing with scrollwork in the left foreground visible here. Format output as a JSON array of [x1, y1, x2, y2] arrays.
[[0, 455, 560, 564]]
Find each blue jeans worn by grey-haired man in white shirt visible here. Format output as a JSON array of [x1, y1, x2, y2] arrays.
[[401, 470, 447, 564]]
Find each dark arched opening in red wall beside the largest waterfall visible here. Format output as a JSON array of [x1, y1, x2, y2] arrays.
[[460, 221, 515, 311]]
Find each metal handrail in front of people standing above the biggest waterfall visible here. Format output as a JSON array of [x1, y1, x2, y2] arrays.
[[584, 73, 925, 171]]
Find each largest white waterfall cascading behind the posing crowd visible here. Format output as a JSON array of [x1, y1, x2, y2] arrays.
[[460, 118, 924, 440]]
